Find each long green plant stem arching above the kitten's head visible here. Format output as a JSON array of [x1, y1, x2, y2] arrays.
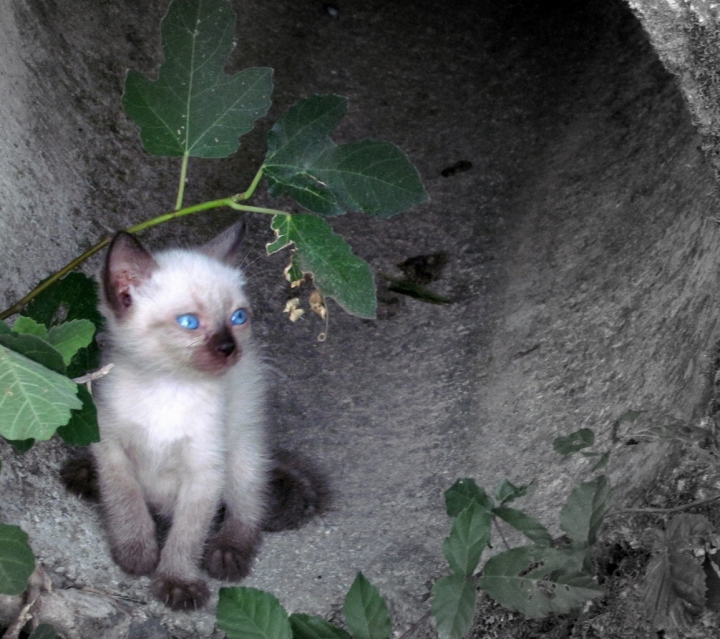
[[0, 195, 289, 319]]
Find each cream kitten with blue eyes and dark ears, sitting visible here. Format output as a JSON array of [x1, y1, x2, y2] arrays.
[[71, 223, 328, 609]]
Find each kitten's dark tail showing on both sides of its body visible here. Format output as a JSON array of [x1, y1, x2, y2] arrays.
[[60, 448, 332, 532]]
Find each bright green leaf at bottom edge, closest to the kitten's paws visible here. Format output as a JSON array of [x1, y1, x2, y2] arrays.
[[217, 587, 292, 639]]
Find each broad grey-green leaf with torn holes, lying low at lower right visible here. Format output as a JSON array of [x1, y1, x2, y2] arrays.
[[479, 546, 603, 618]]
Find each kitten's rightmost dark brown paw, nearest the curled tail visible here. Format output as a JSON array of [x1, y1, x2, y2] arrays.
[[203, 525, 261, 581]]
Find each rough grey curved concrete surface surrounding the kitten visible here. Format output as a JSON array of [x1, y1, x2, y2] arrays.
[[0, 0, 720, 637]]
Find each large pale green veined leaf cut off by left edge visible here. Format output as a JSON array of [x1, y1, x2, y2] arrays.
[[0, 336, 82, 440]]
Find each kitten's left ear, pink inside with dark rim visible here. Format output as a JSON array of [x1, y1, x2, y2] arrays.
[[102, 231, 157, 317]]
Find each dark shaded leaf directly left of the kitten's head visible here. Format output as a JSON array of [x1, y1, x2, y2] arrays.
[[22, 273, 104, 377]]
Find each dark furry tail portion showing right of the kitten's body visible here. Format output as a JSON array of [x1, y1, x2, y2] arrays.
[[263, 450, 332, 532]]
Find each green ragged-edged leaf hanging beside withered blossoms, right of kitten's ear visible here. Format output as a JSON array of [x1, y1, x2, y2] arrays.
[[267, 214, 376, 319]]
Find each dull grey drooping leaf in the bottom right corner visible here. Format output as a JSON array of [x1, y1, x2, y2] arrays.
[[643, 515, 712, 632]]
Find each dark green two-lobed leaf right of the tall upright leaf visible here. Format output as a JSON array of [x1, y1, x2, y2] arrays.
[[263, 95, 428, 217]]
